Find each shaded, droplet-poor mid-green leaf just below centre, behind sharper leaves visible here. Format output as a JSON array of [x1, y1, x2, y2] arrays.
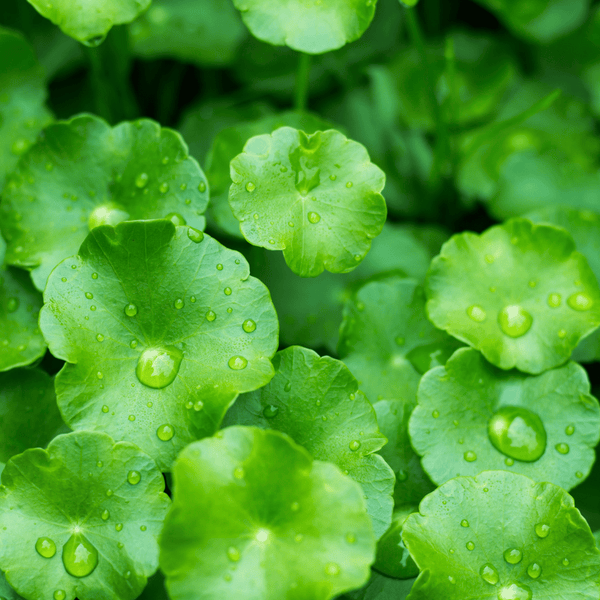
[[339, 276, 459, 403]]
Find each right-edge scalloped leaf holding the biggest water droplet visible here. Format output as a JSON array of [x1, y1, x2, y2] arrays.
[[409, 348, 600, 490]]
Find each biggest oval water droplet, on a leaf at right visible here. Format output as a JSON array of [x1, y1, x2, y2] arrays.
[[488, 406, 546, 462]]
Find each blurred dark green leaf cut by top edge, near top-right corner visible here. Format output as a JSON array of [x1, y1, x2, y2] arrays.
[[477, 0, 590, 44]]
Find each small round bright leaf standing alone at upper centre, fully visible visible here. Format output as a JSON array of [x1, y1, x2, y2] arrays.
[[229, 127, 386, 277]]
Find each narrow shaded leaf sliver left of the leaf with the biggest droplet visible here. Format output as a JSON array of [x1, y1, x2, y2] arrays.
[[373, 400, 435, 506]]
